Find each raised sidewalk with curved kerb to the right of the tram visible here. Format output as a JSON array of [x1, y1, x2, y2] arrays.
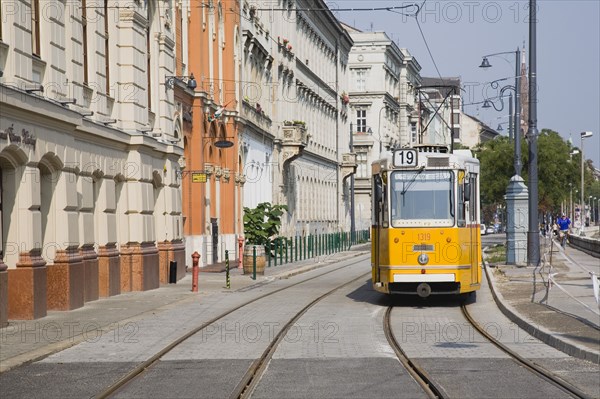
[[485, 237, 600, 363]]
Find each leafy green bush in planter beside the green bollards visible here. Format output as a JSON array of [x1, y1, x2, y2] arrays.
[[243, 202, 288, 274]]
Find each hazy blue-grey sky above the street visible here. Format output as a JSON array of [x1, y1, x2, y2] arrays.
[[327, 0, 600, 168]]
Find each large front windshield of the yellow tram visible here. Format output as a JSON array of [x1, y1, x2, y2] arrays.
[[390, 169, 454, 227]]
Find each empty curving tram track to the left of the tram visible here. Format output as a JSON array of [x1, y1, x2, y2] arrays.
[[94, 259, 370, 398]]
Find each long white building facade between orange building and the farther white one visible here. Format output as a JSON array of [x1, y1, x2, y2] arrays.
[[241, 0, 355, 236]]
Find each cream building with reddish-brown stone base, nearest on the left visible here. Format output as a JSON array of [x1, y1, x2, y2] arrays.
[[0, 0, 185, 319]]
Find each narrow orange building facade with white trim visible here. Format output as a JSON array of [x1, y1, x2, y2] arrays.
[[181, 0, 244, 265]]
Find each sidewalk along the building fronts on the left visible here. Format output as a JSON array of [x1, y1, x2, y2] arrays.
[[0, 243, 370, 373]]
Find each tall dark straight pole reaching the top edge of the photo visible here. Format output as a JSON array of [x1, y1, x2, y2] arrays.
[[527, 0, 540, 267]]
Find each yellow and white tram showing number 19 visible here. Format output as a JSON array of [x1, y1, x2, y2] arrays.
[[371, 146, 481, 297]]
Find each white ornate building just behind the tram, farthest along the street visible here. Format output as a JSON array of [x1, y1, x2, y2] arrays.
[[344, 25, 421, 233]]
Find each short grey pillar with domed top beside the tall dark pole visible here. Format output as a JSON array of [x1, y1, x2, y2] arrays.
[[504, 175, 529, 266]]
